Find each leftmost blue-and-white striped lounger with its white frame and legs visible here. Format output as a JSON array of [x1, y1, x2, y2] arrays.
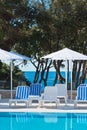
[[9, 86, 29, 106]]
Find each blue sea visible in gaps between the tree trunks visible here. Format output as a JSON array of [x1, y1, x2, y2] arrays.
[[24, 71, 87, 89]]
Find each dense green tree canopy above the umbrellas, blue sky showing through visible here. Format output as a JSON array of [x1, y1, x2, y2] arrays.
[[0, 0, 87, 56]]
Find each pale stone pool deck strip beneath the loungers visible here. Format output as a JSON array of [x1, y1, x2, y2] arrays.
[[0, 100, 87, 113]]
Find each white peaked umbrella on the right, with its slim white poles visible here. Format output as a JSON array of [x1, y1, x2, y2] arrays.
[[42, 48, 87, 99]]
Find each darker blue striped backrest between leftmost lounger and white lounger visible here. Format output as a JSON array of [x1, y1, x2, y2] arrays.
[[29, 84, 41, 96]]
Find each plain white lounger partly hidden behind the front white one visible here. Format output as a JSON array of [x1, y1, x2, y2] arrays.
[[55, 84, 68, 104]]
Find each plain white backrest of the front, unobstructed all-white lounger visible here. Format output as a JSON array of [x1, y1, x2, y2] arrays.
[[44, 86, 57, 100]]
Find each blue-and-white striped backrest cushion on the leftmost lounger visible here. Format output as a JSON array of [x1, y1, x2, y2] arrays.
[[16, 86, 29, 99]]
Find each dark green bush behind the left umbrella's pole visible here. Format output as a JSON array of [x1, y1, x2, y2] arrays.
[[0, 62, 30, 89]]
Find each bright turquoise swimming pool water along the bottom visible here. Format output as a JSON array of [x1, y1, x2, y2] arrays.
[[0, 112, 87, 130]]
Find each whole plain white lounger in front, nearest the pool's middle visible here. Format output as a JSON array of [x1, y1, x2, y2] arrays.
[[39, 86, 59, 107]]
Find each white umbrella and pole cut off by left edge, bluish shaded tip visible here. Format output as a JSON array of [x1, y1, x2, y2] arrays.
[[0, 49, 30, 98]]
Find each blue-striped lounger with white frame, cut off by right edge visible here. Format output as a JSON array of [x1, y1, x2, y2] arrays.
[[74, 84, 87, 107]]
